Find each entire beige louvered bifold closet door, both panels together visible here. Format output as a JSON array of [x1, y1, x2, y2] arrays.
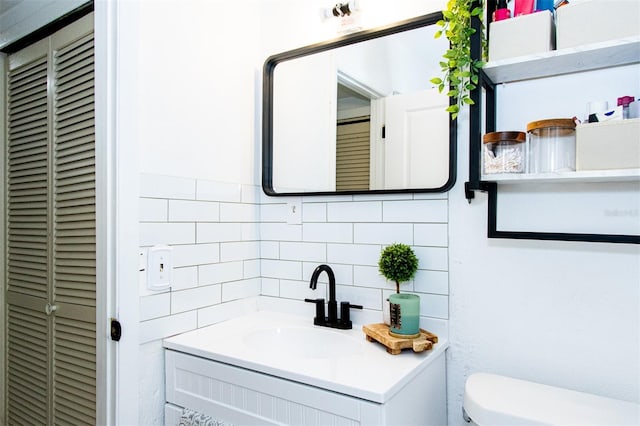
[[7, 15, 96, 425]]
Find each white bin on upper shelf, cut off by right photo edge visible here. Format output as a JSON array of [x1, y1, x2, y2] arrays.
[[556, 0, 640, 49]]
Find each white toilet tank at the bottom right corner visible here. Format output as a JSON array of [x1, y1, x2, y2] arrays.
[[464, 373, 640, 426]]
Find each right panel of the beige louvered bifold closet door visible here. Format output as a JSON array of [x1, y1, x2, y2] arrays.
[[53, 27, 96, 424]]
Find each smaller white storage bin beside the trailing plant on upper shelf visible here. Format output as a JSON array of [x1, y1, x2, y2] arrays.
[[489, 10, 555, 61]]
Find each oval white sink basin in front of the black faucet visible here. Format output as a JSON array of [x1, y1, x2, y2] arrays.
[[243, 327, 362, 358]]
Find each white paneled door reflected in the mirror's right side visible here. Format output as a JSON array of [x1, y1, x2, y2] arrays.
[[382, 89, 449, 189]]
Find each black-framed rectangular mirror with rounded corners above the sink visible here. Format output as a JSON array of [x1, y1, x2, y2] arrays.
[[262, 12, 455, 195]]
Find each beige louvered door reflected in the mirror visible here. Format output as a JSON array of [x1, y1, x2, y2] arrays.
[[336, 117, 370, 191]]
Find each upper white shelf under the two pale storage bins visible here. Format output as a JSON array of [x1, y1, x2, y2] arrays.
[[483, 36, 640, 84]]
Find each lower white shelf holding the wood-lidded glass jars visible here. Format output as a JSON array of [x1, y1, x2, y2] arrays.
[[482, 169, 640, 184]]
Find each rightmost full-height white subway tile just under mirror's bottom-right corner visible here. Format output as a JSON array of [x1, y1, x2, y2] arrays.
[[383, 200, 448, 223]]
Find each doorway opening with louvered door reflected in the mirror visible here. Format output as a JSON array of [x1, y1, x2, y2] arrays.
[[336, 78, 371, 191]]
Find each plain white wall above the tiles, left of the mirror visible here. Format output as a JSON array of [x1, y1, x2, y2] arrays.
[[134, 0, 260, 183]]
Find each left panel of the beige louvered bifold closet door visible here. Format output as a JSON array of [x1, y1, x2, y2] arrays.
[[7, 38, 51, 424]]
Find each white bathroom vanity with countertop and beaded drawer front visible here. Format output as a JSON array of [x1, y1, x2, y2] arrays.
[[164, 311, 447, 426]]
